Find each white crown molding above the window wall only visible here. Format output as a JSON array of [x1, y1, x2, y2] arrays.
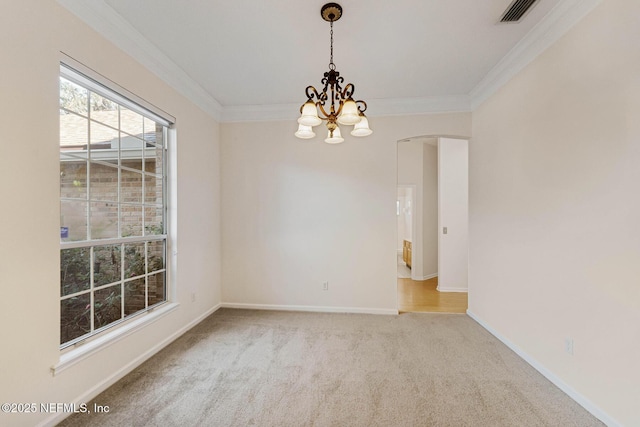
[[57, 0, 222, 121]]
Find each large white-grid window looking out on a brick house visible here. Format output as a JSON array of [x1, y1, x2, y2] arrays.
[[60, 64, 170, 348]]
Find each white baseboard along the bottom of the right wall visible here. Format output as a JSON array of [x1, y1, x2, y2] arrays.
[[467, 310, 622, 427]]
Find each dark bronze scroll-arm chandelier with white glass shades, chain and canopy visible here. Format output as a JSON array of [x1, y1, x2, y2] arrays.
[[295, 3, 373, 144]]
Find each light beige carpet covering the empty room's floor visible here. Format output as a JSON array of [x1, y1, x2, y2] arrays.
[[61, 309, 603, 427]]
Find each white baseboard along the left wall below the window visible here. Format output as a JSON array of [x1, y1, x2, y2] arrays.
[[38, 304, 222, 427]]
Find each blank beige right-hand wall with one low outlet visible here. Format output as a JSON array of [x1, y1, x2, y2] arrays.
[[469, 0, 640, 426]]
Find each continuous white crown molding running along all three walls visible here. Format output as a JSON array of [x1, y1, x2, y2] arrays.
[[57, 0, 602, 122]]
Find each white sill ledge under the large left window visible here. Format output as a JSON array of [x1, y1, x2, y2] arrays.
[[51, 303, 180, 376]]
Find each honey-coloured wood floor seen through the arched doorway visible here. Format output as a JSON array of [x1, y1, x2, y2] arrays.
[[398, 277, 468, 313]]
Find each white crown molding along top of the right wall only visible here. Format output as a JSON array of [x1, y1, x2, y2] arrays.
[[469, 0, 602, 110]]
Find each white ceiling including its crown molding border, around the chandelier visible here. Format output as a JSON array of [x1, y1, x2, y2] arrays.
[[58, 0, 593, 120]]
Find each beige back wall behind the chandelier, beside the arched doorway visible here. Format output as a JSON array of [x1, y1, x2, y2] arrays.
[[221, 113, 471, 313]]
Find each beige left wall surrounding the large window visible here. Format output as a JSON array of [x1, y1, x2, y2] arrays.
[[0, 0, 221, 426]]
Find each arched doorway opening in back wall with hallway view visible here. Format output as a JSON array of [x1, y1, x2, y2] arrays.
[[396, 136, 468, 313]]
